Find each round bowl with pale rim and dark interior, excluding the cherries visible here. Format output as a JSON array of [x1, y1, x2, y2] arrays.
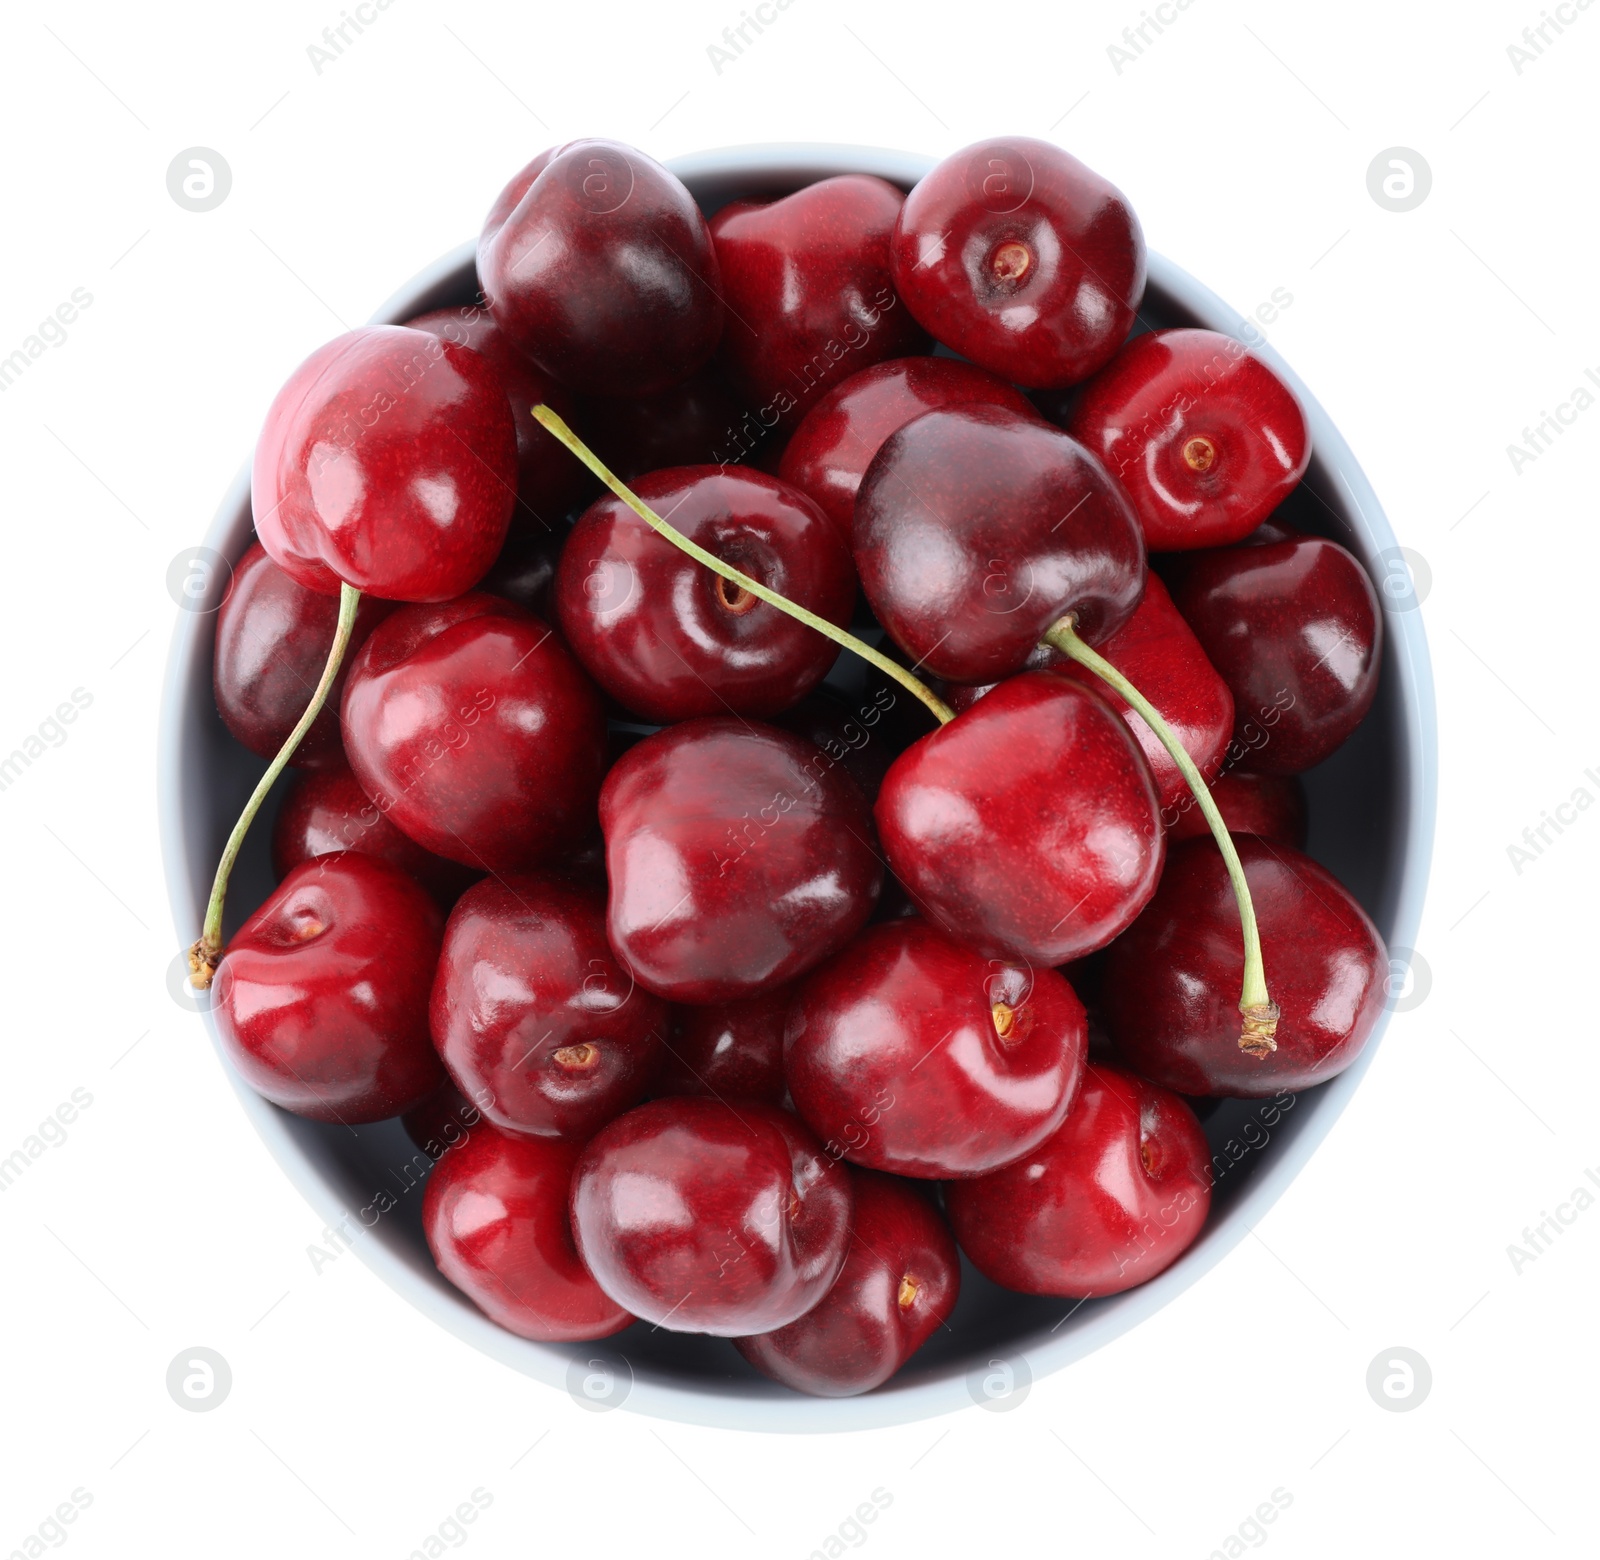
[[158, 146, 1437, 1432]]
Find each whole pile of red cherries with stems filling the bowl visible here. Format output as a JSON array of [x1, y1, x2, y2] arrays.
[[203, 139, 1387, 1395]]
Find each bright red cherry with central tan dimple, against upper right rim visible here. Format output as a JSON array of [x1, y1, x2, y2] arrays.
[[1066, 330, 1310, 552]]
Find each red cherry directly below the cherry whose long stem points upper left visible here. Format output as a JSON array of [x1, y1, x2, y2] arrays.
[[784, 920, 1088, 1179]]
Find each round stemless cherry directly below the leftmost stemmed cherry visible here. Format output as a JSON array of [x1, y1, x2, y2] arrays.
[[342, 594, 606, 872]]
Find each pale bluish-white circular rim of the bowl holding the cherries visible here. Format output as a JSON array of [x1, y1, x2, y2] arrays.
[[157, 142, 1438, 1434]]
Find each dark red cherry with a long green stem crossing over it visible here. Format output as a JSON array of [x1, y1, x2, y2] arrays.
[[555, 466, 856, 722]]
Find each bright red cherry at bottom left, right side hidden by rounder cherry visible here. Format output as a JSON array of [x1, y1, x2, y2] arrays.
[[422, 1126, 634, 1342]]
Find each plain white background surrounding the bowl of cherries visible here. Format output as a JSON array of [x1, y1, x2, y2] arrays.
[[0, 0, 1600, 1560]]
